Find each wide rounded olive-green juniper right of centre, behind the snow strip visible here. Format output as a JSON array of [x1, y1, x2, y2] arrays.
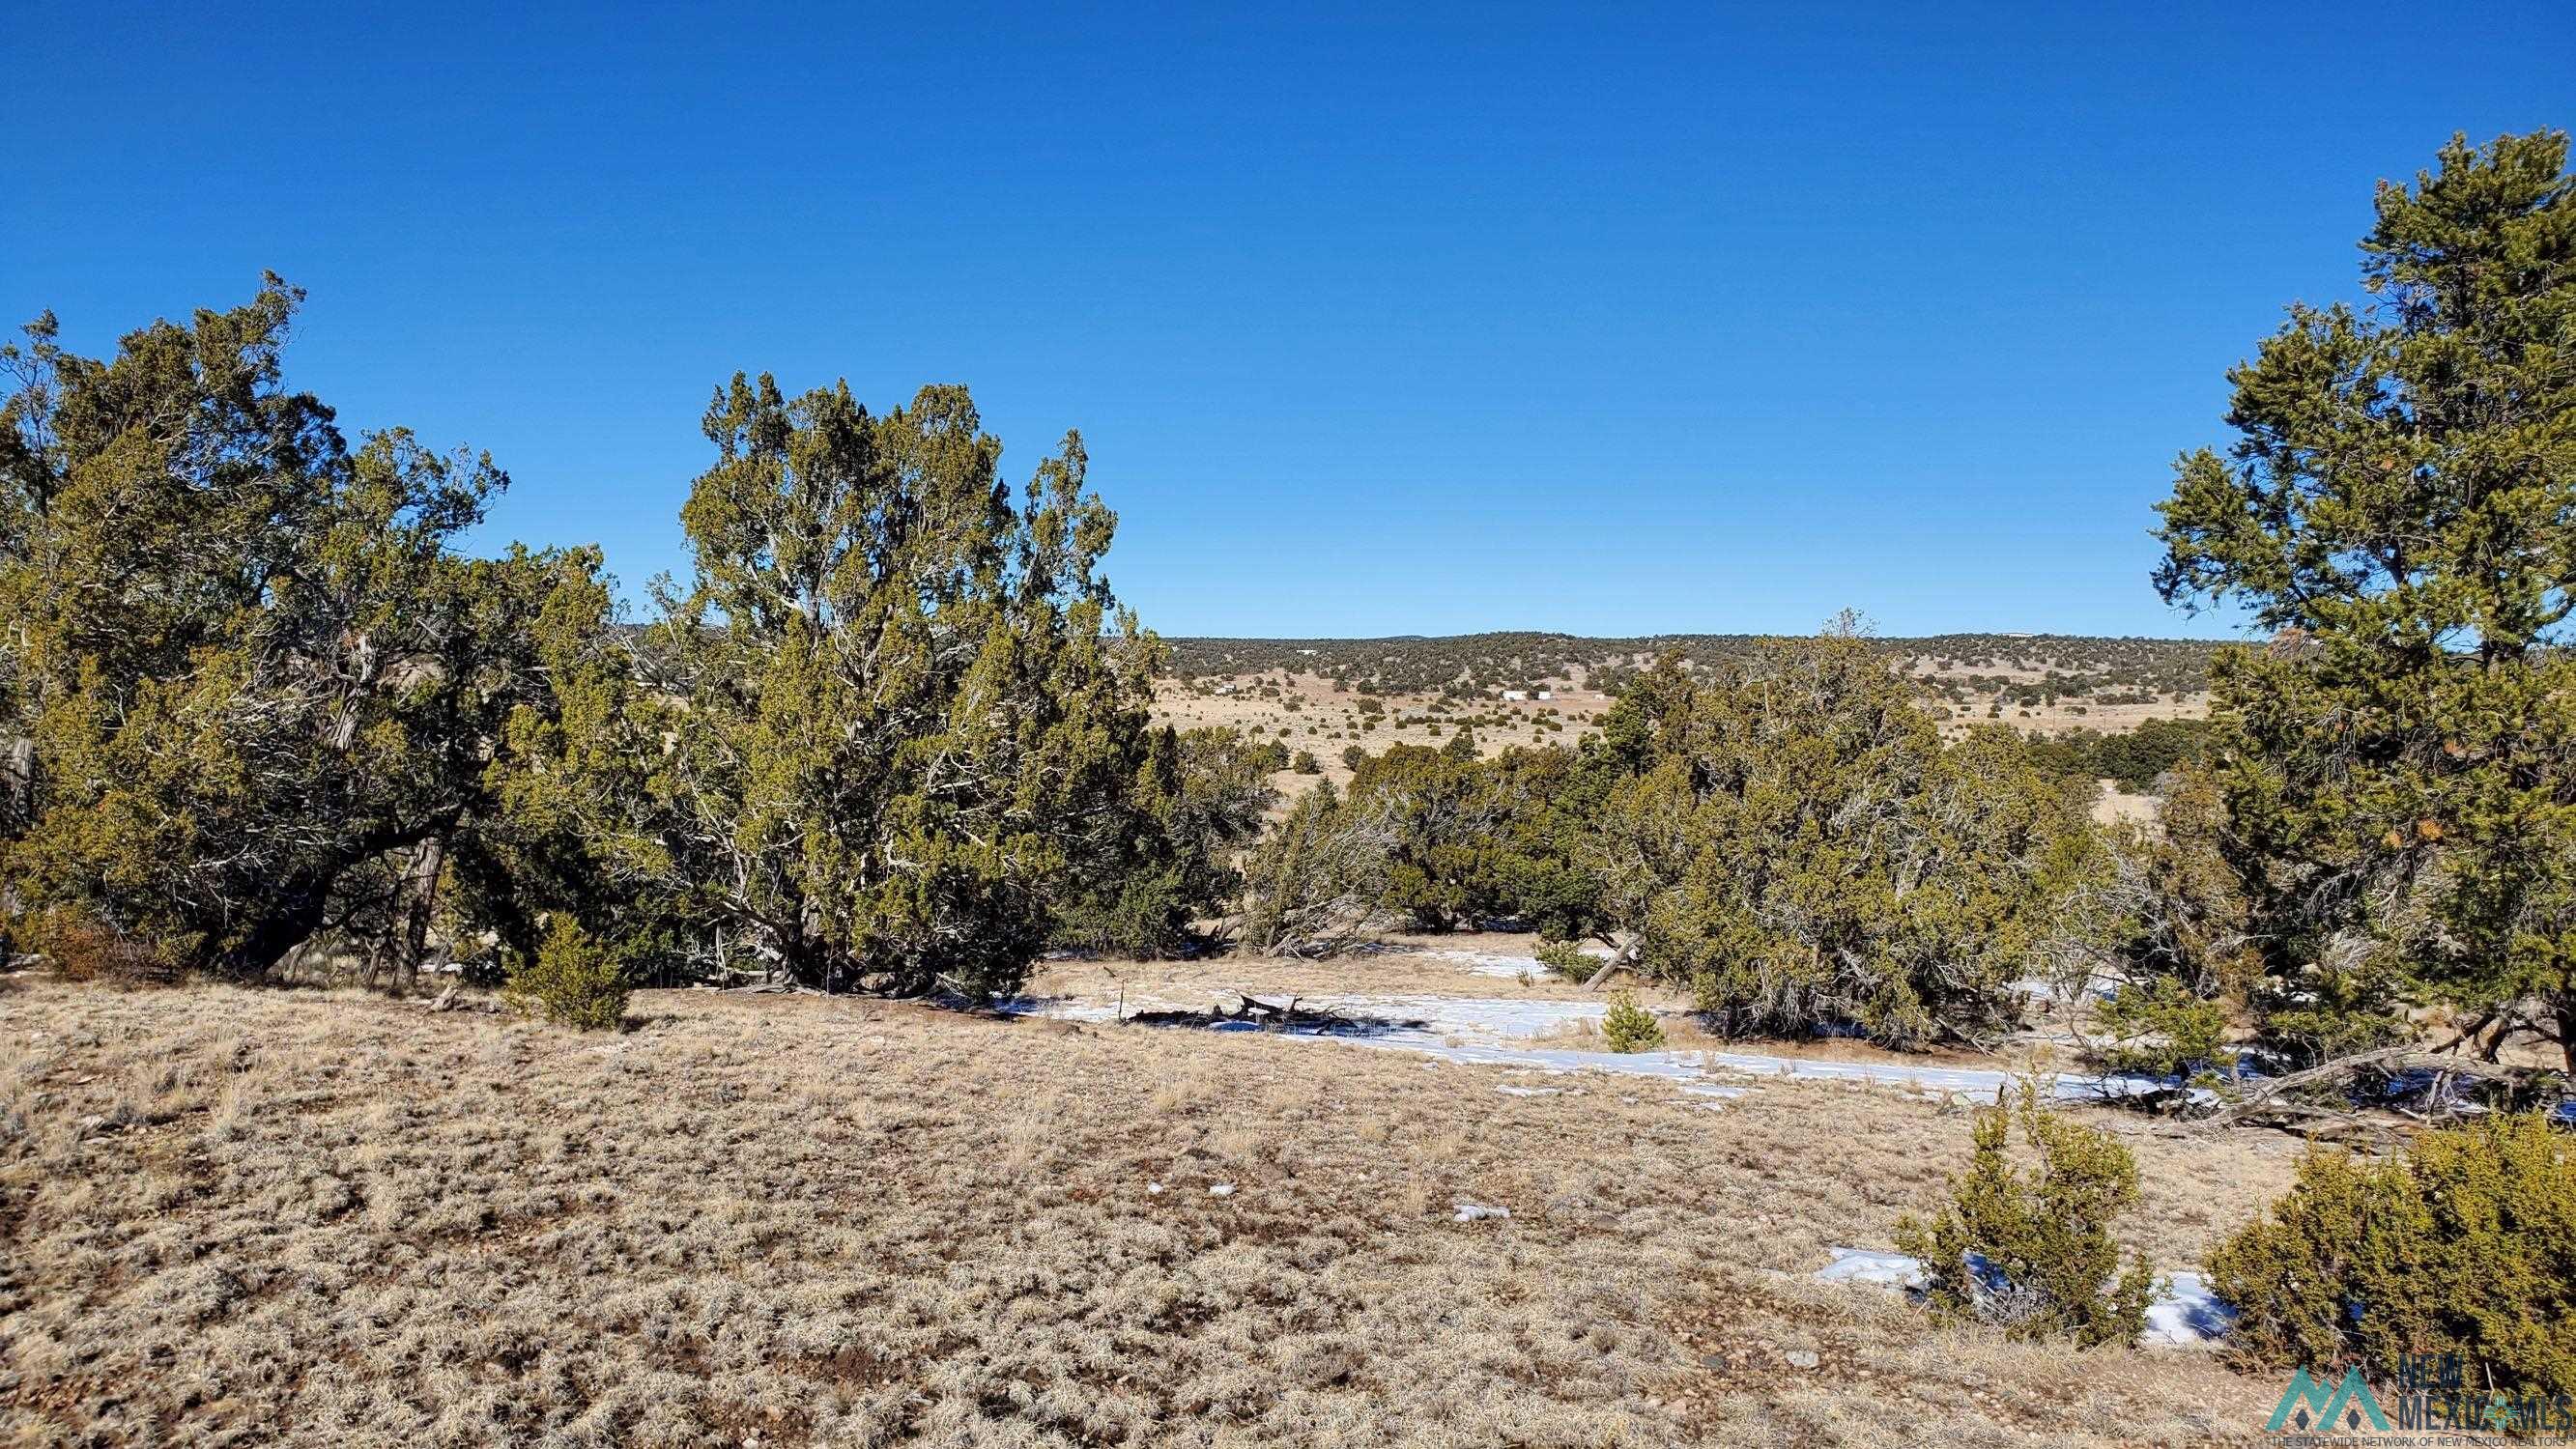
[[1589, 631, 2092, 1047]]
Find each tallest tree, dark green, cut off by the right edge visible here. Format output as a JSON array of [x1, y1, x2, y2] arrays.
[[2159, 131, 2576, 1065]]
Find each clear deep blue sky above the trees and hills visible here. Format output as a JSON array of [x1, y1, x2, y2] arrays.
[[0, 0, 2576, 636]]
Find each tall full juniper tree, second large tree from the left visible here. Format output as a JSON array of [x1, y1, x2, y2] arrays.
[[600, 376, 1154, 993]]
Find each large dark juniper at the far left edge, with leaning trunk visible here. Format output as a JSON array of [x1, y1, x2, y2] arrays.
[[0, 278, 613, 980]]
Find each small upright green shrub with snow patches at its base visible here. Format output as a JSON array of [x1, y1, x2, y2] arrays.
[[1896, 1081, 2156, 1349]]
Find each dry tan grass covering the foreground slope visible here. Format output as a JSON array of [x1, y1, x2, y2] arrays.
[[0, 983, 2287, 1446]]
